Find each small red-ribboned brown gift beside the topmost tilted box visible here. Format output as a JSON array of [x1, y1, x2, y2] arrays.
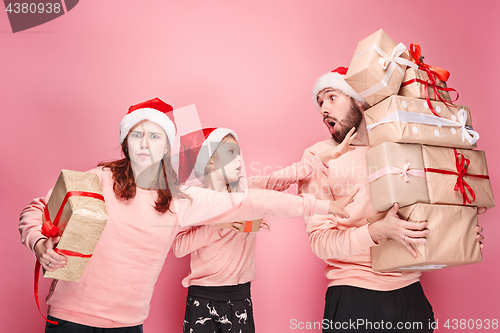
[[398, 68, 451, 102]]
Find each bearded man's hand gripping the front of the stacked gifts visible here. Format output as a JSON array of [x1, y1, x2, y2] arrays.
[[368, 203, 429, 257]]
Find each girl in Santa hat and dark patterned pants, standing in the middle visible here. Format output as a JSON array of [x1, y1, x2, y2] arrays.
[[172, 128, 355, 333]]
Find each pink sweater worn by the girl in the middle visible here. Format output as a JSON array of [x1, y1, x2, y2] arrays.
[[172, 156, 326, 287]]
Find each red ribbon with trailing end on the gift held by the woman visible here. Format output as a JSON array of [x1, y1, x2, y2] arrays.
[[35, 191, 104, 325]]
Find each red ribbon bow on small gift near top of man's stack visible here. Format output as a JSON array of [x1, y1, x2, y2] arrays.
[[402, 43, 458, 117]]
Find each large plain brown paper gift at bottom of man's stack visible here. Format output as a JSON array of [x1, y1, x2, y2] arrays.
[[371, 204, 482, 271]]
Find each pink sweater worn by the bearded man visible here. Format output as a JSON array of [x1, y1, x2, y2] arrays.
[[299, 138, 420, 290]]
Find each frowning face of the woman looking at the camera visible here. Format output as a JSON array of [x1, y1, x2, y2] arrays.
[[127, 120, 168, 177]]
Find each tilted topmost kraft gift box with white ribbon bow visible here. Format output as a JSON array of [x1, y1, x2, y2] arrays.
[[345, 29, 418, 105]]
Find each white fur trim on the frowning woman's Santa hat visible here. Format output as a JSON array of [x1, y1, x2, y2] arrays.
[[120, 108, 175, 146]]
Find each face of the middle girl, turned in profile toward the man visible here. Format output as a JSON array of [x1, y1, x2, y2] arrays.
[[209, 135, 241, 185]]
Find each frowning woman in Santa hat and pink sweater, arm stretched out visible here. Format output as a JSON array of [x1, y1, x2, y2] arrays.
[[19, 98, 352, 333]]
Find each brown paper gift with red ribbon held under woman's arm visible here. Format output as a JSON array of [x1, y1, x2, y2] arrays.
[[44, 170, 108, 282]]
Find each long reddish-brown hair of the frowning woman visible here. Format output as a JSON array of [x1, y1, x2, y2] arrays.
[[98, 138, 191, 213]]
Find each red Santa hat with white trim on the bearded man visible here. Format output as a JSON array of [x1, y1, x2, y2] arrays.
[[312, 67, 369, 109]]
